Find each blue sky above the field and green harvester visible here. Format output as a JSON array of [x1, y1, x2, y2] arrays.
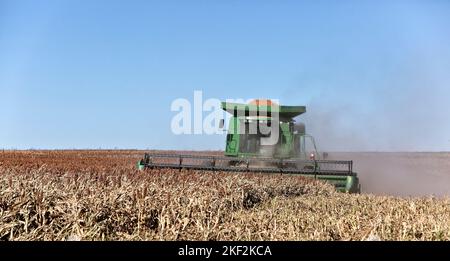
[[0, 0, 450, 151]]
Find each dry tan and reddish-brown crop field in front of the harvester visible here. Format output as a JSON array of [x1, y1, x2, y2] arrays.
[[0, 150, 450, 241]]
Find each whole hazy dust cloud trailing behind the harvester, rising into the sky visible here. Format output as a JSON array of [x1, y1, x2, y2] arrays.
[[286, 65, 450, 196]]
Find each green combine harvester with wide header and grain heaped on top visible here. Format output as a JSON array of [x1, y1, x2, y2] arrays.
[[138, 100, 361, 193]]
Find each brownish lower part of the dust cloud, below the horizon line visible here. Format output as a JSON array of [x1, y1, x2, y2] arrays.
[[329, 152, 450, 197]]
